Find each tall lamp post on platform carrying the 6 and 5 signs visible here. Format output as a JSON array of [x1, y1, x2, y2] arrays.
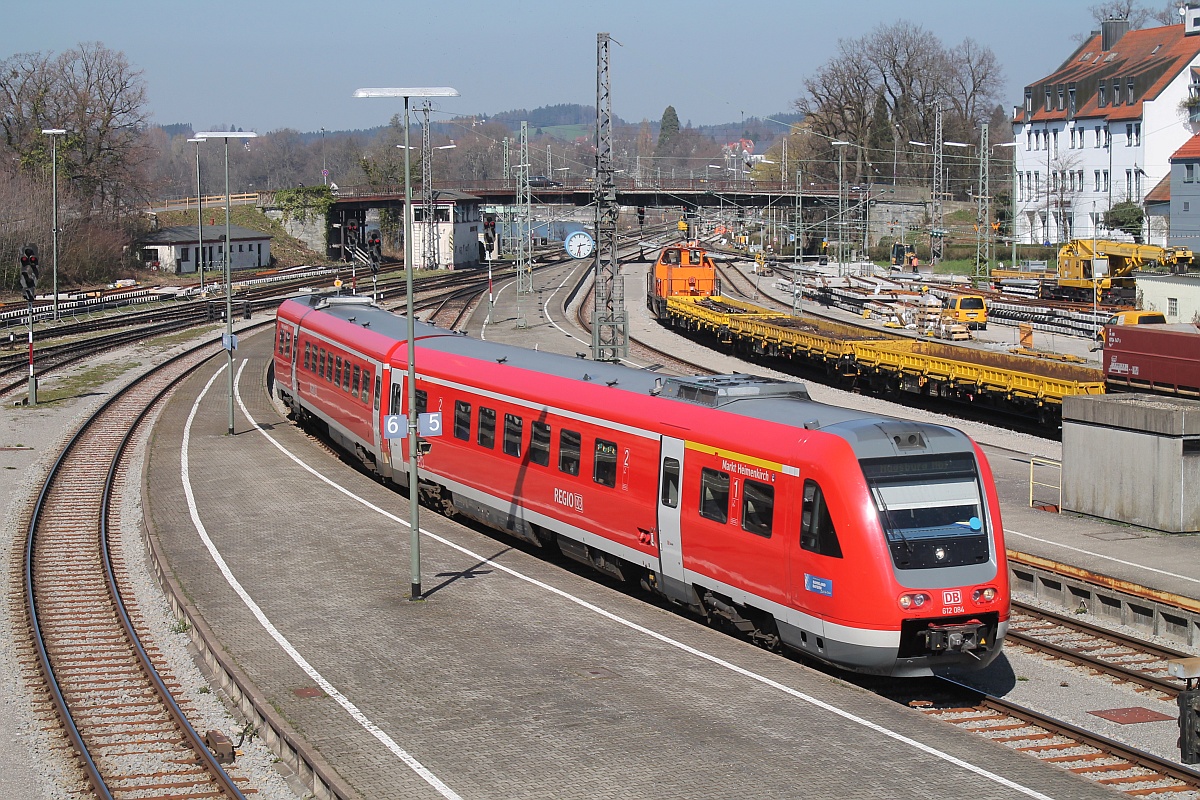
[[354, 86, 458, 600]]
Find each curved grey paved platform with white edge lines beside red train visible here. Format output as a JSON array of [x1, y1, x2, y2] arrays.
[[146, 304, 1111, 799]]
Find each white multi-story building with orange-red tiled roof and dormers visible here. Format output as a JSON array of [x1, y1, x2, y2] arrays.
[[1013, 12, 1200, 245]]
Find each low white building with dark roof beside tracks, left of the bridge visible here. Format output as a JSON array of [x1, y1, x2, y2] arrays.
[[137, 225, 271, 275]]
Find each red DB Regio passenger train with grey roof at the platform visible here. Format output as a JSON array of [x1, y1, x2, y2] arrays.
[[274, 296, 1009, 675]]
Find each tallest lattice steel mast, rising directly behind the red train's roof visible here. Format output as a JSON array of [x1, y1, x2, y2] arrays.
[[592, 34, 629, 361]]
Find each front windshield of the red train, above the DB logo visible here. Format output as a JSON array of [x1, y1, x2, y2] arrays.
[[862, 453, 989, 570]]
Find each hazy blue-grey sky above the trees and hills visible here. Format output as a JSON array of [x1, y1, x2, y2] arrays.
[[7, 0, 1123, 133]]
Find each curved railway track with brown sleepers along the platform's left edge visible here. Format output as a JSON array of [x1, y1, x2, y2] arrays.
[[17, 335, 264, 799]]
